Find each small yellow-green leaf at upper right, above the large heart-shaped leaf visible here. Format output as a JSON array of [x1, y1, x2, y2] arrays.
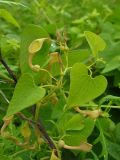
[[84, 31, 106, 57]]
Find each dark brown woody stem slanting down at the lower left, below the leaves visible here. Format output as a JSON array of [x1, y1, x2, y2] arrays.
[[17, 113, 58, 157]]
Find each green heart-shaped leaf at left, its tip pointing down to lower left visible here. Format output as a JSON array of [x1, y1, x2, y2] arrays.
[[6, 74, 45, 117]]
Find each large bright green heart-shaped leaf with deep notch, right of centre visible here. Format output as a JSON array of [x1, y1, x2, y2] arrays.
[[68, 63, 107, 107]]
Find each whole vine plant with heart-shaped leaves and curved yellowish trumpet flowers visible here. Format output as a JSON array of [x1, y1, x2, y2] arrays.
[[1, 25, 107, 160]]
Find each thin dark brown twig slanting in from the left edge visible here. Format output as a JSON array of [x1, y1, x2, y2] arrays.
[[0, 50, 17, 83]]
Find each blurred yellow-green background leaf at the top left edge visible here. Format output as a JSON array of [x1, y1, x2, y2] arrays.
[[0, 9, 20, 28]]
